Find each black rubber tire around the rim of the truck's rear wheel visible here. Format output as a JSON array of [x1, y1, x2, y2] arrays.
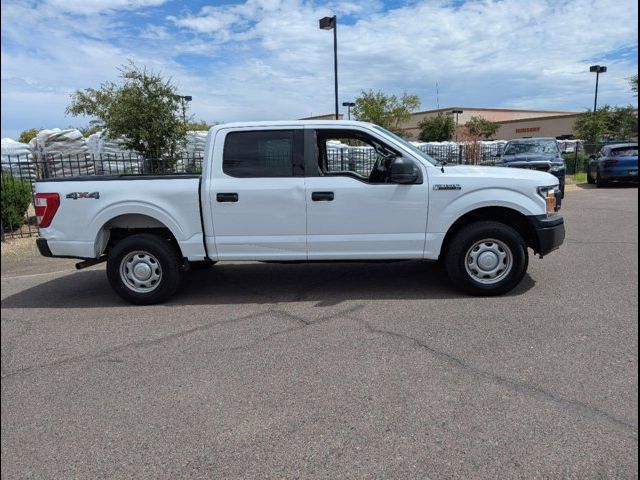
[[107, 233, 184, 305]]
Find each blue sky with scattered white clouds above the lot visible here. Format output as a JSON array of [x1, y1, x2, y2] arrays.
[[1, 0, 638, 137]]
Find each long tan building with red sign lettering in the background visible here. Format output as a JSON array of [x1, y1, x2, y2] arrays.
[[402, 107, 579, 140]]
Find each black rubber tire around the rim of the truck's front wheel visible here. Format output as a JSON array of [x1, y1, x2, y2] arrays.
[[445, 221, 529, 296]]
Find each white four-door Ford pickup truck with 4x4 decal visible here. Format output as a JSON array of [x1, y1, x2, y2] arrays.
[[36, 121, 565, 304]]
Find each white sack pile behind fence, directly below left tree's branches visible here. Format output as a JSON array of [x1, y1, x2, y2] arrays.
[[87, 132, 143, 175]]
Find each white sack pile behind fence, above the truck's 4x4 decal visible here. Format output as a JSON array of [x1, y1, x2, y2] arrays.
[[29, 128, 95, 177]]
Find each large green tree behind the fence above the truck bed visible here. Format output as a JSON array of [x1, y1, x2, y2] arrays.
[[67, 62, 186, 170]]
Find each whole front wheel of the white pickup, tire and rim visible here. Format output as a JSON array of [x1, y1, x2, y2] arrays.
[[445, 221, 529, 296]]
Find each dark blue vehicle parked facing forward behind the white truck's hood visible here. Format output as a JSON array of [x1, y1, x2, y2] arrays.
[[496, 138, 567, 198]]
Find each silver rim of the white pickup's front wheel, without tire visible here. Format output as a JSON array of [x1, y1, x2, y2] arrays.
[[464, 238, 513, 285]]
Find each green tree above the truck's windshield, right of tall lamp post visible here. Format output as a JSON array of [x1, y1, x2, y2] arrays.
[[352, 90, 420, 136]]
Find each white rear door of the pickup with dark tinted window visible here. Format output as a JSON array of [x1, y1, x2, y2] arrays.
[[210, 127, 307, 260]]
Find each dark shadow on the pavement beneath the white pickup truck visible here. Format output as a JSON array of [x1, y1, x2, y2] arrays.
[[2, 261, 535, 308]]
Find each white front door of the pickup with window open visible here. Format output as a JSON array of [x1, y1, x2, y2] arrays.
[[305, 128, 428, 260]]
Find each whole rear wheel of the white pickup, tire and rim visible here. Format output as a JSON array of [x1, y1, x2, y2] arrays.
[[107, 233, 183, 305]]
